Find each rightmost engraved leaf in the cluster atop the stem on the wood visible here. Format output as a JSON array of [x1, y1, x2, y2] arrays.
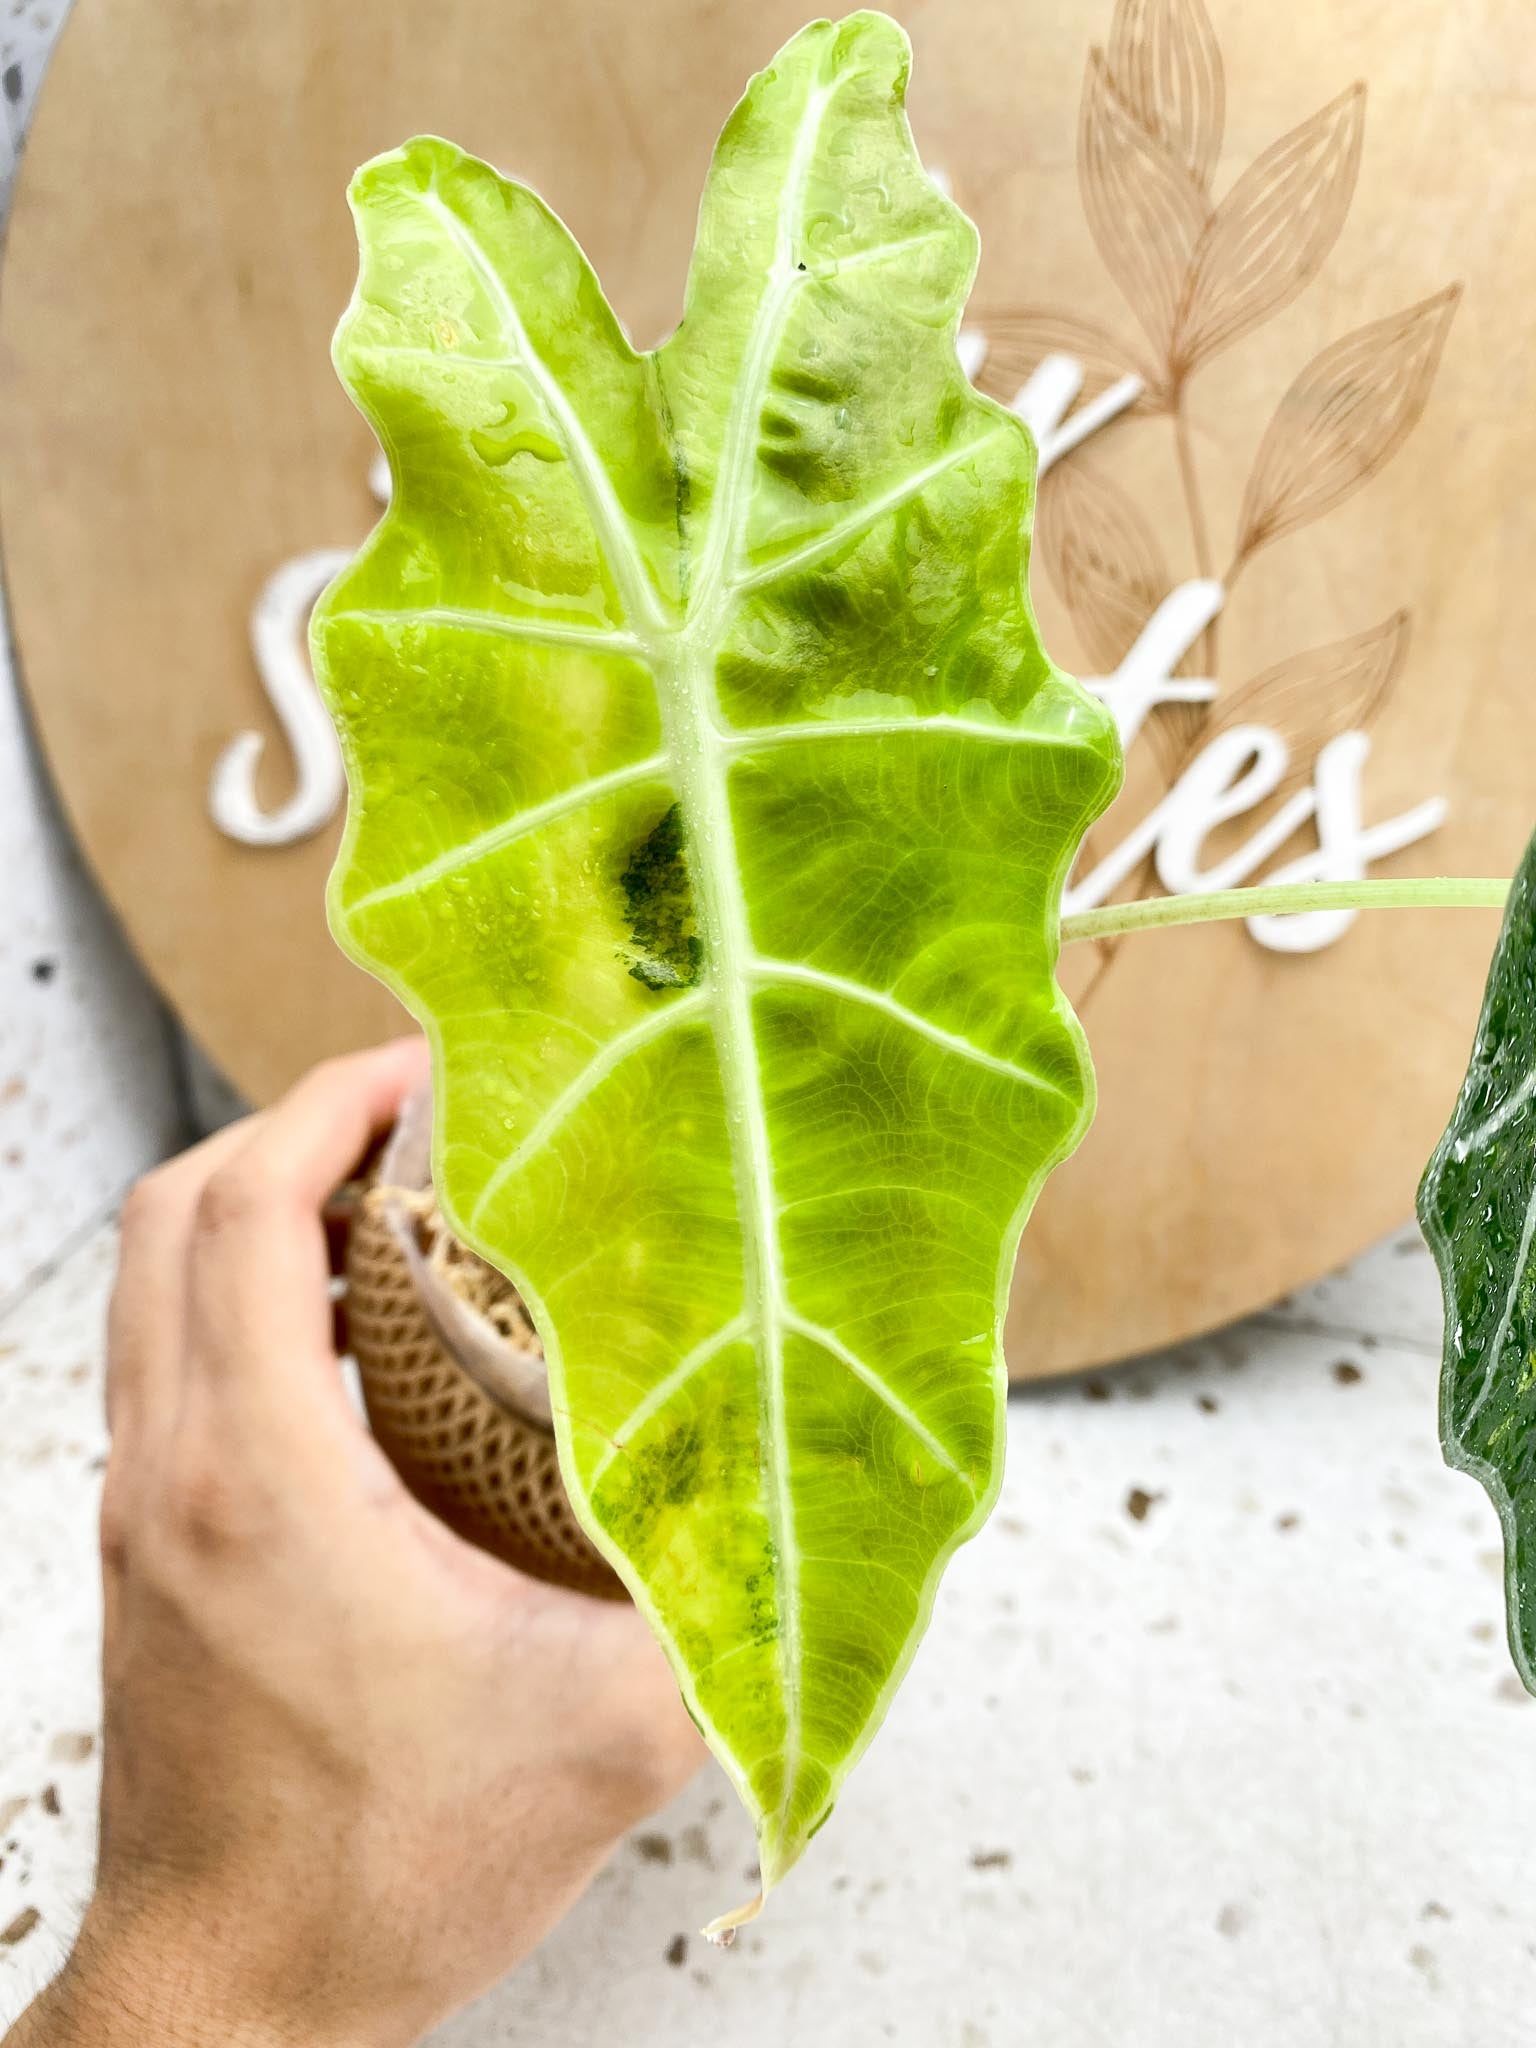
[[1169, 84, 1366, 383]]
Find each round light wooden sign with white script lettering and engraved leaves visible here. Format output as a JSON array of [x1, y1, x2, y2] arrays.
[[0, 0, 1536, 1376]]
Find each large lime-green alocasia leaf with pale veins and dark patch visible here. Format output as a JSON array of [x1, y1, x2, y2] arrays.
[[313, 14, 1118, 1886]]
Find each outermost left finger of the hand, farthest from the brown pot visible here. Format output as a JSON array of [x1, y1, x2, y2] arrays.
[[106, 1116, 256, 1438]]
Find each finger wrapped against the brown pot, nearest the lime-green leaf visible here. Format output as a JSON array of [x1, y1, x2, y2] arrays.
[[188, 1038, 426, 1434]]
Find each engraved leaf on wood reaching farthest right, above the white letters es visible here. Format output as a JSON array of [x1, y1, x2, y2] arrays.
[[1227, 285, 1460, 584]]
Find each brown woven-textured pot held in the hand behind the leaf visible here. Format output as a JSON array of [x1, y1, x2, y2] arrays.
[[346, 1096, 625, 1599]]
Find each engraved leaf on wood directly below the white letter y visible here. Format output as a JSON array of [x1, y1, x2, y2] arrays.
[[1034, 463, 1169, 676]]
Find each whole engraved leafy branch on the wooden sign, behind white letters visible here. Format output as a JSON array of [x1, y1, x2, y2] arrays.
[[985, 0, 1460, 1001]]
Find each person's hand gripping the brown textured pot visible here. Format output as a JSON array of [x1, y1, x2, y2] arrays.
[[12, 1040, 705, 2048]]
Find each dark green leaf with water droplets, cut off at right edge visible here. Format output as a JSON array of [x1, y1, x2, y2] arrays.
[[1419, 819, 1536, 1692]]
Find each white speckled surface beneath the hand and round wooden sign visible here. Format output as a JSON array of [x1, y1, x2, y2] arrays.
[[0, 1212, 1536, 2048]]
